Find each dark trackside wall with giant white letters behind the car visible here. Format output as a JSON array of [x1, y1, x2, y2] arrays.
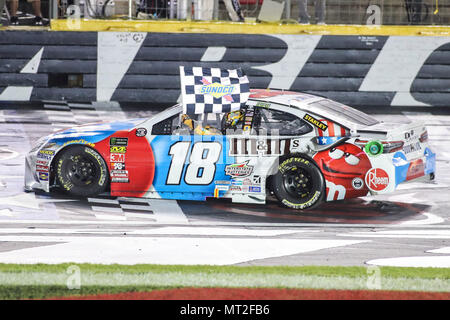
[[0, 31, 450, 107]]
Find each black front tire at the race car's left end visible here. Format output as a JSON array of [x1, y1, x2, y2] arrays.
[[54, 145, 109, 197]]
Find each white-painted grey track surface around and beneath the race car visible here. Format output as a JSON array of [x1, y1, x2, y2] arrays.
[[0, 102, 450, 267]]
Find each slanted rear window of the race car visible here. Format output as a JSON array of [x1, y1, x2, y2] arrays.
[[309, 99, 379, 126]]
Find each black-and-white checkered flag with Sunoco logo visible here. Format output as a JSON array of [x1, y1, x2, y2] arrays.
[[180, 66, 250, 114]]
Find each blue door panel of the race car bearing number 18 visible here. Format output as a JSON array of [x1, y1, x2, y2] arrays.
[[151, 110, 230, 200]]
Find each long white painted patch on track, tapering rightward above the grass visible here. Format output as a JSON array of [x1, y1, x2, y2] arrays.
[[0, 236, 365, 265]]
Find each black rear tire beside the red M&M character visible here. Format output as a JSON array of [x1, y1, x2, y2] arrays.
[[272, 155, 325, 210]]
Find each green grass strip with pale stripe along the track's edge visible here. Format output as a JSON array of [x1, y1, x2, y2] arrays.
[[0, 264, 450, 299]]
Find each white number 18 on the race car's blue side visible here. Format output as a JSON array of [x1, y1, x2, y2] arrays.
[[166, 141, 222, 185]]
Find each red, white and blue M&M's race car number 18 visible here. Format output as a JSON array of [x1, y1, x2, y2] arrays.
[[25, 89, 435, 209]]
